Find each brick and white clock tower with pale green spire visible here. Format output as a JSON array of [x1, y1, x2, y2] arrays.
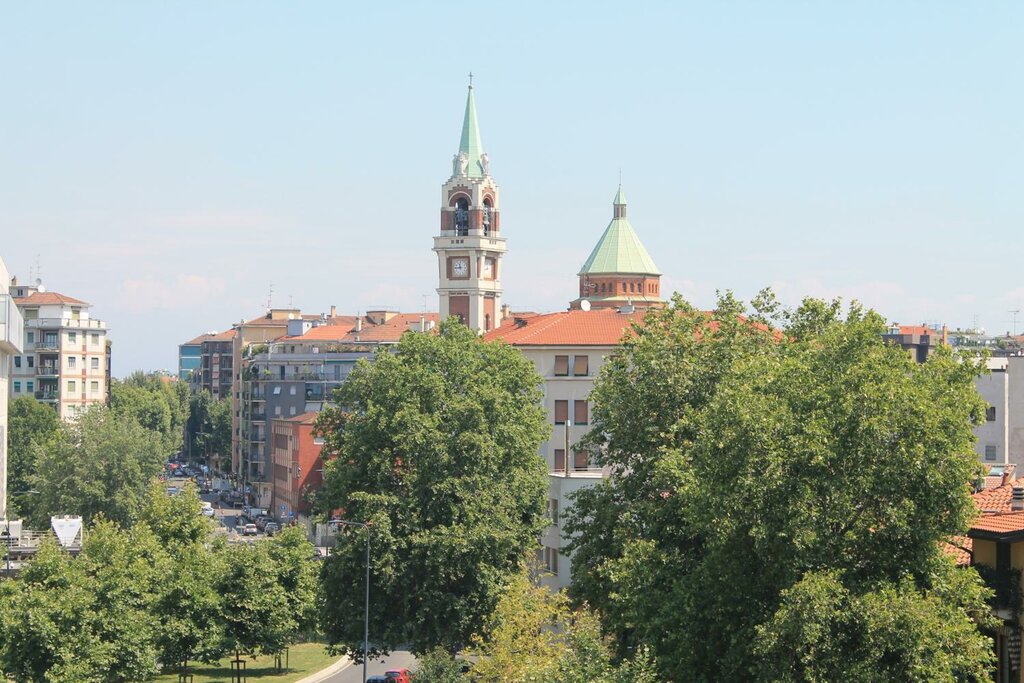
[[434, 83, 506, 333]]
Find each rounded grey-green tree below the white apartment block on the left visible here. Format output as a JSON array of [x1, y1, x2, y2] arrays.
[[26, 407, 164, 528]]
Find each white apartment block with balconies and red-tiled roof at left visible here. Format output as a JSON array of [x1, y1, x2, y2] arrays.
[[8, 280, 111, 420]]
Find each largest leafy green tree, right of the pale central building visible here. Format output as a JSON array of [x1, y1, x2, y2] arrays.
[[563, 293, 987, 680]]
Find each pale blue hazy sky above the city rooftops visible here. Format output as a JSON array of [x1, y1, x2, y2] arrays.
[[0, 0, 1024, 376]]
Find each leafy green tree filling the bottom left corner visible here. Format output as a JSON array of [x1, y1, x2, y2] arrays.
[[0, 520, 161, 683]]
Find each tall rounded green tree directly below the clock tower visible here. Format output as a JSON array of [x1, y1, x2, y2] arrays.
[[319, 321, 549, 656]]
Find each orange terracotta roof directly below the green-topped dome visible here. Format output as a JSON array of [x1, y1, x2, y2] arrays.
[[483, 308, 645, 346]]
